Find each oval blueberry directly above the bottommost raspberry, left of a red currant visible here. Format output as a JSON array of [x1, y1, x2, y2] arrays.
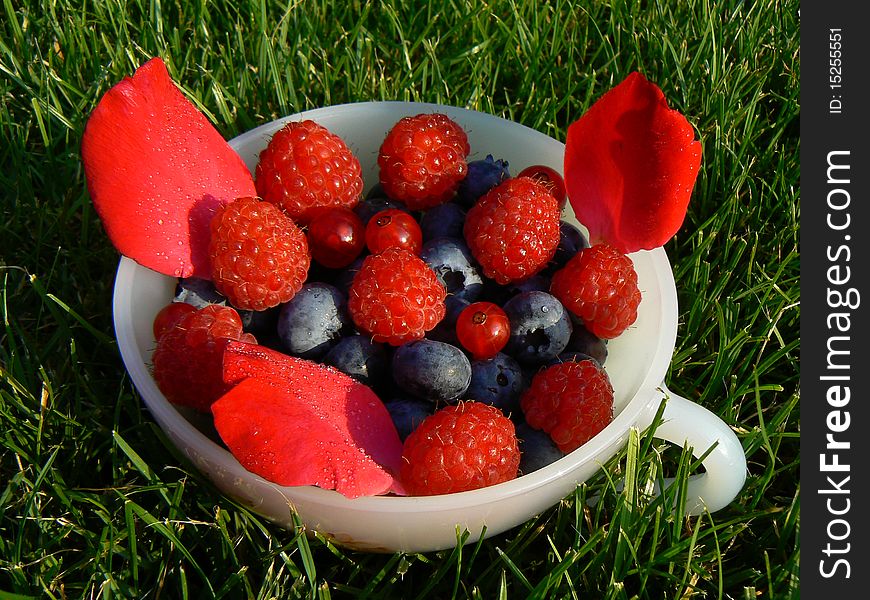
[[393, 339, 471, 402]]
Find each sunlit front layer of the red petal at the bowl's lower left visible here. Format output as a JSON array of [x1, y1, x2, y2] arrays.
[[212, 377, 393, 498]]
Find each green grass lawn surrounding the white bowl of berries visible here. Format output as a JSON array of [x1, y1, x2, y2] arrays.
[[0, 0, 800, 600]]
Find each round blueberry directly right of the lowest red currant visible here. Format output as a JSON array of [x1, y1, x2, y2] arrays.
[[503, 291, 573, 364]]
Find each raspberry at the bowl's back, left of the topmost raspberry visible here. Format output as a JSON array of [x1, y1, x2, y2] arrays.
[[255, 121, 363, 223]]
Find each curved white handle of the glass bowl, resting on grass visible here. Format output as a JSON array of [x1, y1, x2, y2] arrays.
[[650, 384, 746, 515]]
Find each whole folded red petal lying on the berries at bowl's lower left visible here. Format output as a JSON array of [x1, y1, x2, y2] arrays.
[[218, 342, 404, 498]]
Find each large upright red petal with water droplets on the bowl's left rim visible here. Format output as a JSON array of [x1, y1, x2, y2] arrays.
[[82, 58, 257, 278]]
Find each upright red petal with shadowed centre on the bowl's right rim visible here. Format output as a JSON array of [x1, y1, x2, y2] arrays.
[[565, 73, 701, 253]]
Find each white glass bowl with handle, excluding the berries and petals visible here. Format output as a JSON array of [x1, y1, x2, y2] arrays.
[[113, 102, 746, 552]]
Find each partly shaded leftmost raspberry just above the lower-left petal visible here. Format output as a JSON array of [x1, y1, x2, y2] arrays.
[[151, 304, 256, 412]]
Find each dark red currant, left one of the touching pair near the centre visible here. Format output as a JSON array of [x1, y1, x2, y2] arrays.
[[308, 206, 365, 269]]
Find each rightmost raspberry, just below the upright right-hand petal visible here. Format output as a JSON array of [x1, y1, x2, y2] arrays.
[[550, 244, 640, 339]]
